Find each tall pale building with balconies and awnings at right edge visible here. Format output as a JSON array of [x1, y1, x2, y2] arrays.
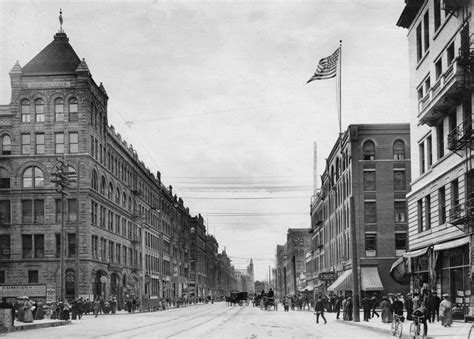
[[393, 0, 474, 316]]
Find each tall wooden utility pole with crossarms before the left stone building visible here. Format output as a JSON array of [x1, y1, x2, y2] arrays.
[[51, 157, 73, 301]]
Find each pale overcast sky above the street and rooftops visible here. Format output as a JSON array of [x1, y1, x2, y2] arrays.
[[0, 0, 409, 279]]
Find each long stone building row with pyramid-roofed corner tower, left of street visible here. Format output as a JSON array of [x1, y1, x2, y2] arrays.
[[0, 23, 233, 304]]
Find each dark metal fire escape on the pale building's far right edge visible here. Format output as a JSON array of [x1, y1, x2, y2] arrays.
[[448, 7, 474, 234]]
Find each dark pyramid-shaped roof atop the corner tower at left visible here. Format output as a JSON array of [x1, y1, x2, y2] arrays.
[[22, 32, 81, 75]]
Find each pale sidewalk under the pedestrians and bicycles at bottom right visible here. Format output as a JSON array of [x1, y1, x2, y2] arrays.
[[338, 312, 474, 339]]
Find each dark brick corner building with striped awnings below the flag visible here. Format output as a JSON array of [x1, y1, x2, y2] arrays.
[[306, 124, 411, 295]]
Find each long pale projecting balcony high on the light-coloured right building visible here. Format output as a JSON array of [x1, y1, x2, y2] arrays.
[[418, 61, 465, 127]]
